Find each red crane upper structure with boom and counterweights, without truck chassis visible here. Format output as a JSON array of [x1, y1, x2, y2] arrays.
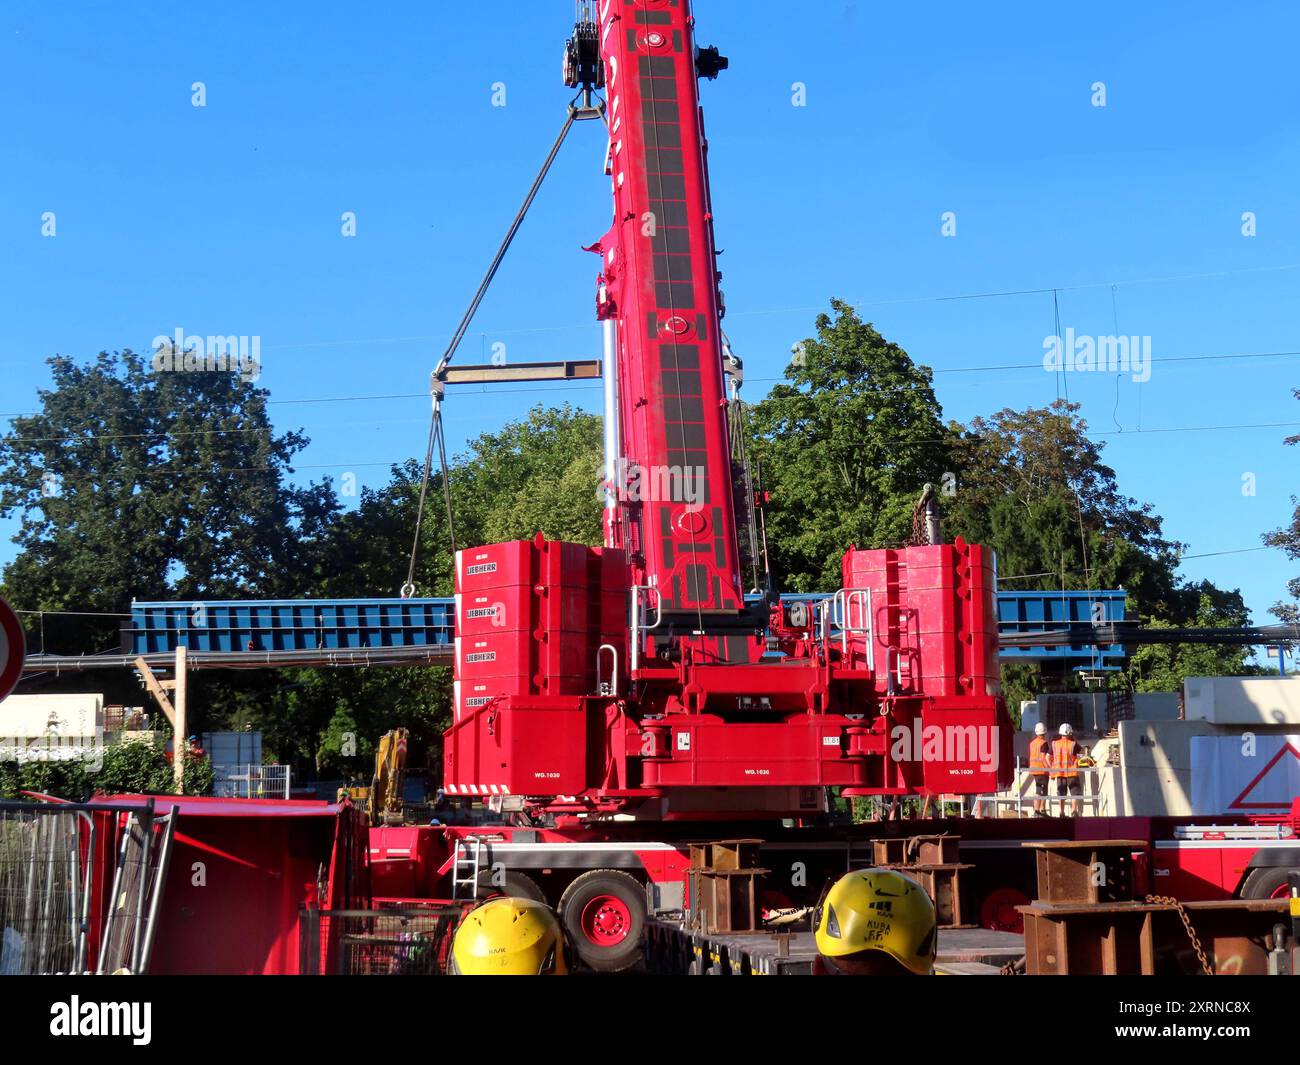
[[445, 0, 1011, 819]]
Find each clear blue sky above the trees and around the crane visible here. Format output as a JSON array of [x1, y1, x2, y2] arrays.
[[0, 0, 1300, 642]]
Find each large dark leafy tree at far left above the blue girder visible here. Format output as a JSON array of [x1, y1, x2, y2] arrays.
[[0, 350, 337, 653]]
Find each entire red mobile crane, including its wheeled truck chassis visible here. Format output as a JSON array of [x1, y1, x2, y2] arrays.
[[369, 0, 1300, 971]]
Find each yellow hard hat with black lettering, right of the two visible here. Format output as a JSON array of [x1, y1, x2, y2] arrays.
[[815, 869, 937, 977]]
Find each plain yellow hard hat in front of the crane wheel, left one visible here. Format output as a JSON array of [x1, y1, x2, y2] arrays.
[[451, 897, 568, 977]]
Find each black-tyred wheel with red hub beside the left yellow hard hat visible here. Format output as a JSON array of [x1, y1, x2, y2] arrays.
[[559, 869, 646, 973]]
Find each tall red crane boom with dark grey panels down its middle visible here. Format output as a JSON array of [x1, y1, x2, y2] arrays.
[[598, 0, 744, 615]]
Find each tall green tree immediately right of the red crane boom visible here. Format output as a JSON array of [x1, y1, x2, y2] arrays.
[[749, 299, 950, 592]]
